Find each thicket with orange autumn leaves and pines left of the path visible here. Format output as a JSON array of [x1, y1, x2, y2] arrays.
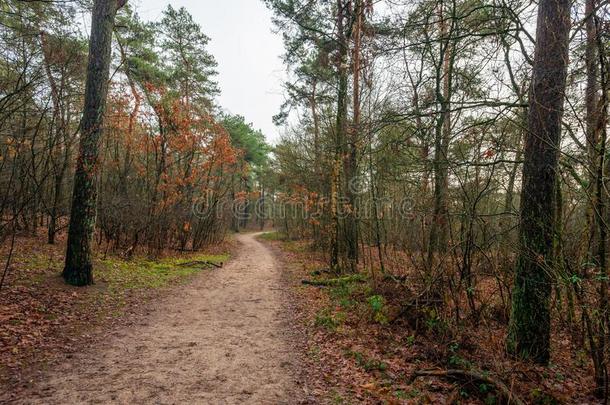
[[0, 1, 268, 272]]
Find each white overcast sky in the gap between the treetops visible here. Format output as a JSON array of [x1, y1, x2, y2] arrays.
[[130, 0, 285, 143]]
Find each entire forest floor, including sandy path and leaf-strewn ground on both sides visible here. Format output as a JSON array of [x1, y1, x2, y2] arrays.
[[0, 229, 596, 405]]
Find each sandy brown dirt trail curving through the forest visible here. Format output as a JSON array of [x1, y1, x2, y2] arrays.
[[11, 234, 299, 404]]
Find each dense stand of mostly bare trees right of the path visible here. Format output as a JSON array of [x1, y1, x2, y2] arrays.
[[266, 0, 610, 395]]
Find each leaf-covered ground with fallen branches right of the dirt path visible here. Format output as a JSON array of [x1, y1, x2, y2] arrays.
[[260, 233, 600, 405]]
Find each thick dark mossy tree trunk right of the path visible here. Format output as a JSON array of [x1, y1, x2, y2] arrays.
[[507, 0, 571, 364]]
